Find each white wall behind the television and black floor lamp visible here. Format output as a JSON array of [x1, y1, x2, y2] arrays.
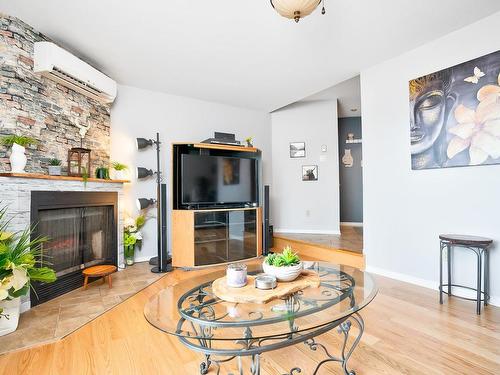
[[111, 86, 271, 259]]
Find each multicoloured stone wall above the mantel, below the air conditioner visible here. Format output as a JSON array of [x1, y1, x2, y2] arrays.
[[0, 13, 111, 175]]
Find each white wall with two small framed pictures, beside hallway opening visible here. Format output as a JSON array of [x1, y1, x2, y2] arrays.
[[271, 101, 340, 233]]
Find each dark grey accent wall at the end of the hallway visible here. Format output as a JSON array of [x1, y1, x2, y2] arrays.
[[339, 117, 363, 223]]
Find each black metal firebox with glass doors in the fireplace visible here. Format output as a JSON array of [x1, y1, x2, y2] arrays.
[[31, 191, 118, 306]]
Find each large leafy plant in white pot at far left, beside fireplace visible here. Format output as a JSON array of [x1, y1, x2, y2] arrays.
[[0, 207, 56, 336]]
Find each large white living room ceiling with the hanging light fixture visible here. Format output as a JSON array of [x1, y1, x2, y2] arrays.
[[0, 0, 500, 111]]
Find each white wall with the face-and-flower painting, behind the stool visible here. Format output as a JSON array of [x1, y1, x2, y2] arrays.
[[361, 13, 500, 306]]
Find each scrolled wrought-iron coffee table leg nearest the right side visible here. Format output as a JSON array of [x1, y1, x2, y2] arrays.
[[304, 313, 365, 375]]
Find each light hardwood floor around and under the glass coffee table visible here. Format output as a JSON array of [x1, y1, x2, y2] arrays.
[[0, 262, 500, 375]]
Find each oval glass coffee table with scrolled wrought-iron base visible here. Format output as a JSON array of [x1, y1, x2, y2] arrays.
[[144, 262, 377, 375]]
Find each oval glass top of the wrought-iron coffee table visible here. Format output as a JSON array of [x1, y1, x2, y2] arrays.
[[144, 262, 377, 340]]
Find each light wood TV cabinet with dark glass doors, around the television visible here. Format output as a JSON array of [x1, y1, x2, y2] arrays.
[[171, 143, 263, 268]]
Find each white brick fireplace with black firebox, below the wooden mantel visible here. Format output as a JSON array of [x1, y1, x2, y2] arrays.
[[0, 173, 124, 310]]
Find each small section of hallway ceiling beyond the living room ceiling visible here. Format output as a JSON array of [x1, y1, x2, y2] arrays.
[[301, 76, 361, 117]]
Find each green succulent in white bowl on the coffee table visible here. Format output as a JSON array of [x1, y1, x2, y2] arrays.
[[262, 246, 303, 281]]
